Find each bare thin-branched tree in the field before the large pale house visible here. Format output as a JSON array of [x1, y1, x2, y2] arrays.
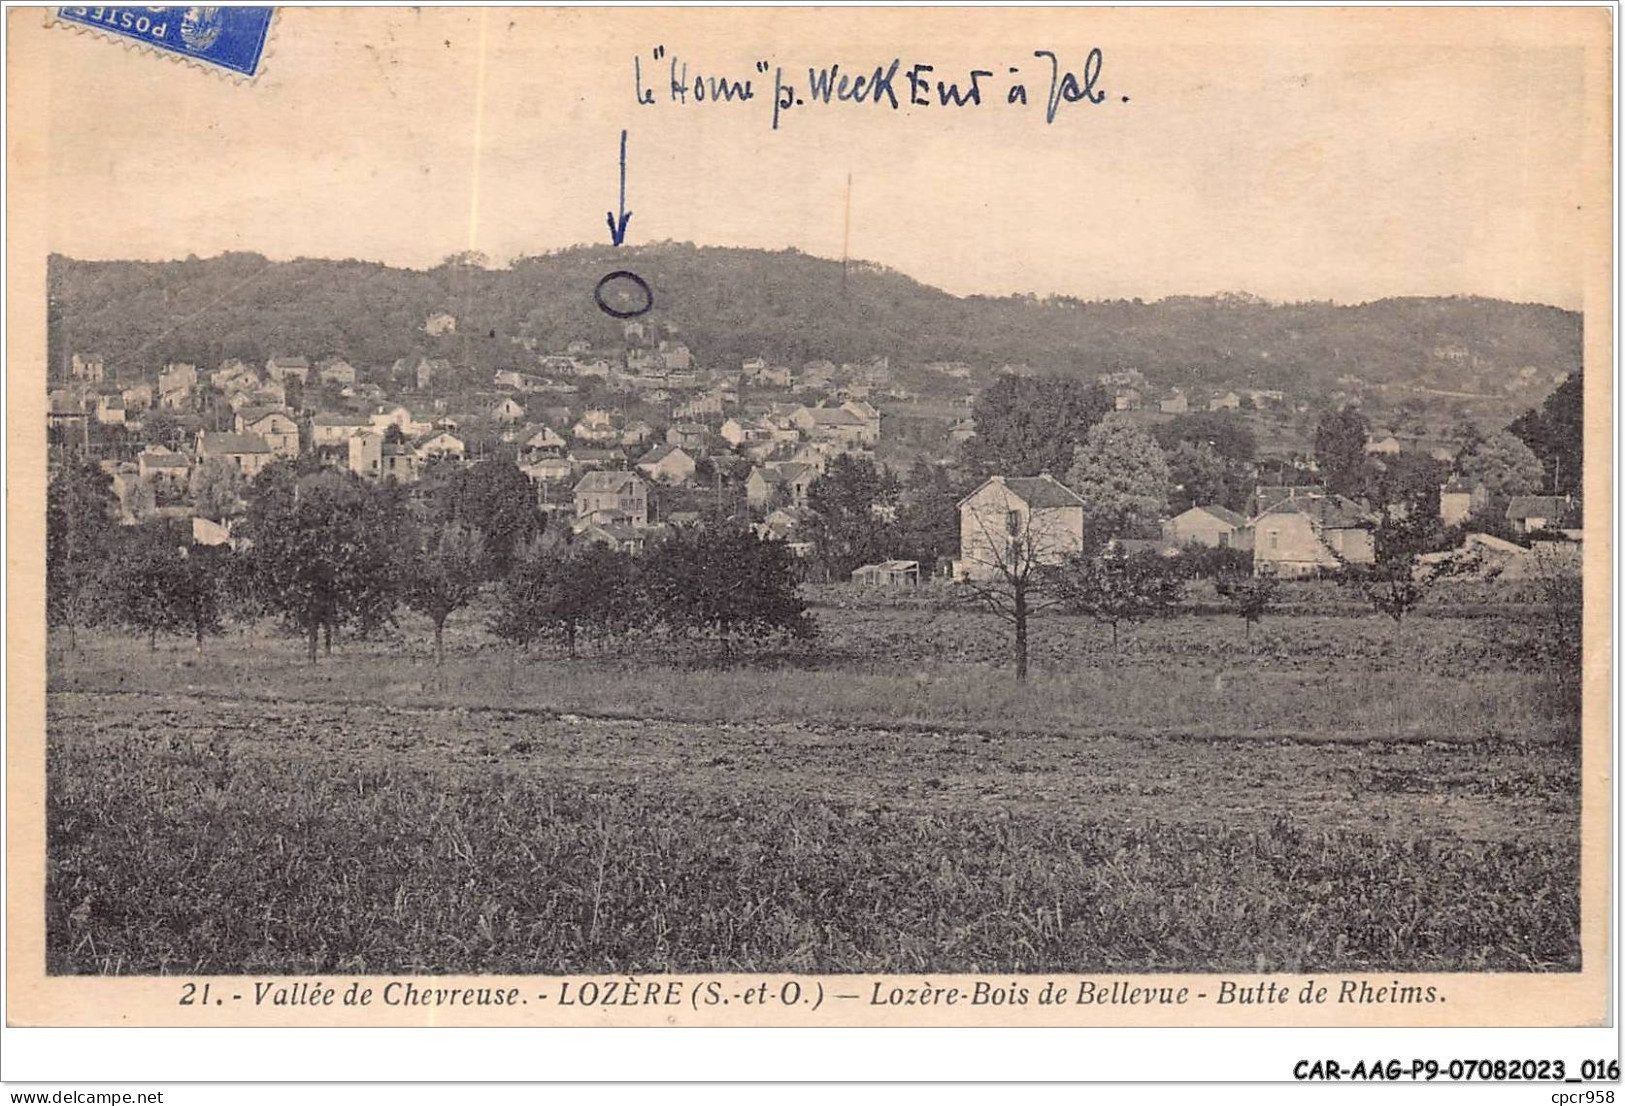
[[959, 476, 1084, 682]]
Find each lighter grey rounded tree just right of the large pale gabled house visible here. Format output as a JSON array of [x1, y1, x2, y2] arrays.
[[1066, 422, 1168, 538]]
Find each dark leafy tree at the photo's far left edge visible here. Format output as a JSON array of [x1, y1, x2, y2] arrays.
[[46, 463, 119, 648]]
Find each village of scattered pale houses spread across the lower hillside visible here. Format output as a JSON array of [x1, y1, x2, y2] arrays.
[[49, 312, 1581, 586]]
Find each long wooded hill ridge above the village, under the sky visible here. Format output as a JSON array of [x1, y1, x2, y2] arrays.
[[50, 244, 1581, 406]]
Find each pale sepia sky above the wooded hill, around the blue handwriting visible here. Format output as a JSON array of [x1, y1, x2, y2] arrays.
[[8, 8, 1609, 309]]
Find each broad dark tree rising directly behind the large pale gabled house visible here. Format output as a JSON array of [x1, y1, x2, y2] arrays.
[[965, 377, 1112, 477]]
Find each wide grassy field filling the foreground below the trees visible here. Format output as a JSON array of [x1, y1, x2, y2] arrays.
[[47, 593, 1580, 973]]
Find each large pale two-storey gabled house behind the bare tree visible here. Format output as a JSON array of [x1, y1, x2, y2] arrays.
[[954, 473, 1084, 580]]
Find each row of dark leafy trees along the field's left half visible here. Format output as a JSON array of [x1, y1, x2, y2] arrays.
[[47, 463, 811, 663]]
